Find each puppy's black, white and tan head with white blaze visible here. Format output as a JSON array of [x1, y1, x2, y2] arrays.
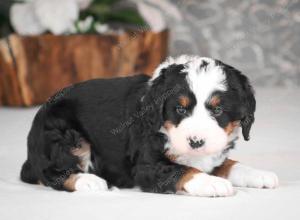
[[143, 56, 256, 155]]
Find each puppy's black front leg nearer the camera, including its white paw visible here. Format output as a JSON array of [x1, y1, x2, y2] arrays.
[[135, 163, 233, 197]]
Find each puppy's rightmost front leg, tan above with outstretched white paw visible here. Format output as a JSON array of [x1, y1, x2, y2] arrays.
[[212, 159, 278, 188]]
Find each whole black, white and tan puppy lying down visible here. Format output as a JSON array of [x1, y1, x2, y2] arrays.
[[21, 55, 278, 197]]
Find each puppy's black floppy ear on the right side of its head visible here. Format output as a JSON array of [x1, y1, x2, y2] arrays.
[[238, 73, 256, 141]]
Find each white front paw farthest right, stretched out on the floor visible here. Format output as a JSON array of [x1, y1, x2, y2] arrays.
[[228, 163, 279, 188]]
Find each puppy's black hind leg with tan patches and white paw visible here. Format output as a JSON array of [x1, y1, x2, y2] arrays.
[[40, 118, 107, 191]]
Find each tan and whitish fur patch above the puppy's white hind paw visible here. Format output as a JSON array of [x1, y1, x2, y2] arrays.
[[71, 139, 91, 172]]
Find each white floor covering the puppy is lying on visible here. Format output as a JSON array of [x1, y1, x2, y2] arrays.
[[0, 89, 300, 220]]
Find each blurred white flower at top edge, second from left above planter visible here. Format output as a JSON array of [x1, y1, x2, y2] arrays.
[[33, 0, 79, 35]]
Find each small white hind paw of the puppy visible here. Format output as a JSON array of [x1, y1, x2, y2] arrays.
[[75, 173, 108, 192]]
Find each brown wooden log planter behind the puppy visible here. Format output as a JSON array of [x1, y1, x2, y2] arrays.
[[0, 30, 168, 106]]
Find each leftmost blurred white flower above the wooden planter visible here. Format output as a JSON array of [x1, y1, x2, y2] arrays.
[[10, 3, 46, 35]]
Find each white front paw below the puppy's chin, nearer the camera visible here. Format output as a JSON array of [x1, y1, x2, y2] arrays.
[[183, 173, 234, 197]]
